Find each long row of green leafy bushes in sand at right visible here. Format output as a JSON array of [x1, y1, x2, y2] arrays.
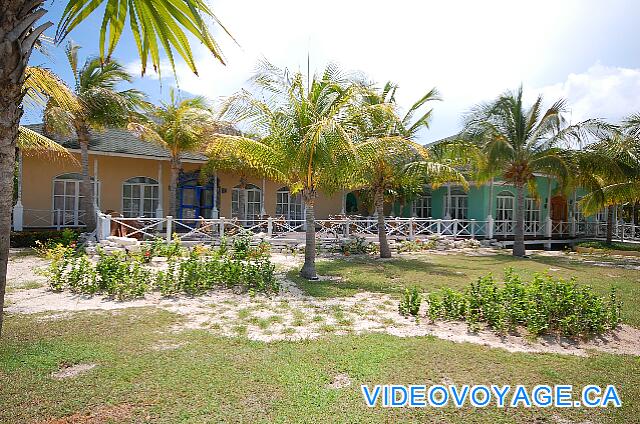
[[427, 269, 621, 337]]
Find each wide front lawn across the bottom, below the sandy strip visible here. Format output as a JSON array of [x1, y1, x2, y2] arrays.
[[0, 308, 640, 423]]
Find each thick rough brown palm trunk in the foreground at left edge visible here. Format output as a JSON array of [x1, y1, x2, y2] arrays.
[[0, 0, 51, 335]]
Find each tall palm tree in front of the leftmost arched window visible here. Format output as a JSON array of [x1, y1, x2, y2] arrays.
[[34, 43, 147, 231]]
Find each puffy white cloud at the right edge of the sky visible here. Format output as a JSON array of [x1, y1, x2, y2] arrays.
[[538, 63, 640, 122]]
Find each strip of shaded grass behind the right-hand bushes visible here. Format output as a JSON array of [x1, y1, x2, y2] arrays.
[[288, 254, 640, 327]]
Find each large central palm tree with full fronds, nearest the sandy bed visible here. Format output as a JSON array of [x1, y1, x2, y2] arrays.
[[209, 62, 360, 279]]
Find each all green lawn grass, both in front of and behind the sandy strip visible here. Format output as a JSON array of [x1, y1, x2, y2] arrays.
[[0, 254, 640, 423]]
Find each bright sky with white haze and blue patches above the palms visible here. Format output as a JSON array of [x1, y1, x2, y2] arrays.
[[23, 0, 640, 143]]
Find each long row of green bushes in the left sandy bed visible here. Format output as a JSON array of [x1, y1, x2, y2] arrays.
[[44, 245, 280, 300]]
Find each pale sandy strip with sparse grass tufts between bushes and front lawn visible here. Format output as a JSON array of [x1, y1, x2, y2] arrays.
[[6, 255, 640, 356]]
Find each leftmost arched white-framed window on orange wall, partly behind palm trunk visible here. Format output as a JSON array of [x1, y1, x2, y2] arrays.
[[53, 172, 100, 225]]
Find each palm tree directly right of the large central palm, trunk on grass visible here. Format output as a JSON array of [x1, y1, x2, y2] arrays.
[[352, 82, 466, 258]]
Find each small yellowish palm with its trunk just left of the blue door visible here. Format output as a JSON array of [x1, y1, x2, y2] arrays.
[[128, 90, 222, 217]]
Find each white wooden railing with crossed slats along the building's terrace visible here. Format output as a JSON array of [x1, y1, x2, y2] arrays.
[[13, 209, 640, 243]]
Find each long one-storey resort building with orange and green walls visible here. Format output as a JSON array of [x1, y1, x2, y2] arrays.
[[13, 125, 624, 240]]
